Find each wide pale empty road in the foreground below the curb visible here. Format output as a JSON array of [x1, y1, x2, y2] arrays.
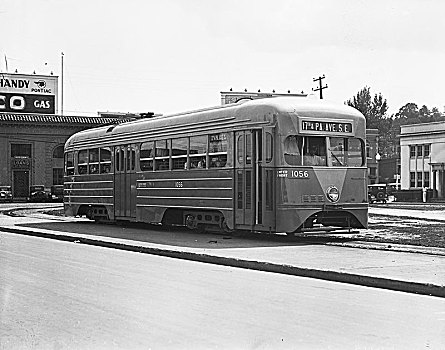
[[0, 233, 445, 349]]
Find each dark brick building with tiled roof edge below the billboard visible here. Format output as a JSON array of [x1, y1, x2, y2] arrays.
[[0, 113, 131, 200]]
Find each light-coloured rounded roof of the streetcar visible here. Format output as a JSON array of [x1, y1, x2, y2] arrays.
[[66, 97, 365, 146]]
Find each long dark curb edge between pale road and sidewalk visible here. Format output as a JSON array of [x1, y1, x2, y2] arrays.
[[0, 227, 445, 298]]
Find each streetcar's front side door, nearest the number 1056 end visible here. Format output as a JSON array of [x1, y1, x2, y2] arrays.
[[234, 130, 262, 229]]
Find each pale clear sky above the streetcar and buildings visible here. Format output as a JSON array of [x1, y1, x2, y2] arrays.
[[0, 0, 445, 115]]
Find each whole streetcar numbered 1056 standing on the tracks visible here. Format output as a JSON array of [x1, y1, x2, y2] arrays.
[[64, 97, 368, 234]]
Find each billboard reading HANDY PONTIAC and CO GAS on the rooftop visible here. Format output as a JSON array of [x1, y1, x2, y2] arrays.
[[0, 73, 58, 114]]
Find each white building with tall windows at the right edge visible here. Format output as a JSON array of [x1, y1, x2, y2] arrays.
[[400, 122, 445, 198]]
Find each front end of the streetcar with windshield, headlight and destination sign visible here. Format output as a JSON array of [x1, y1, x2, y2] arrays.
[[276, 106, 368, 233]]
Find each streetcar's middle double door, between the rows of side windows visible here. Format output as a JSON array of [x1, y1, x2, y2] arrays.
[[114, 145, 136, 218]]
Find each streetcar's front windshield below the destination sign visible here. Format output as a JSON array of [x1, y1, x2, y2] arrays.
[[284, 135, 364, 167]]
